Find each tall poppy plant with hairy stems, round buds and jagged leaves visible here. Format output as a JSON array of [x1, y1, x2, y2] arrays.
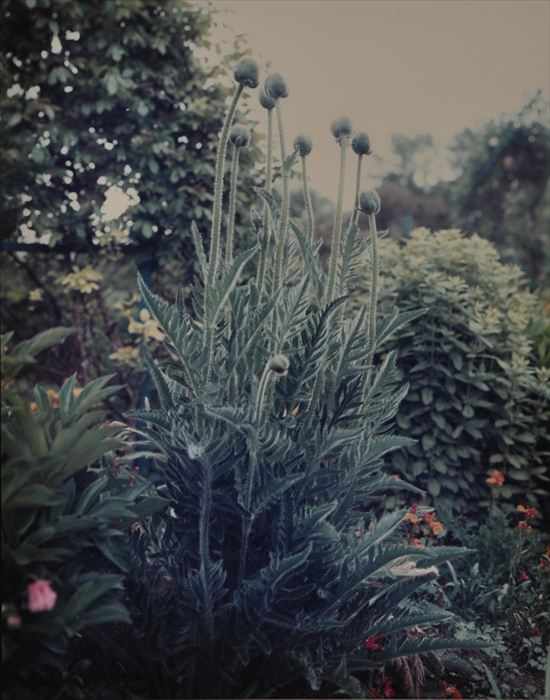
[[99, 61, 492, 697]]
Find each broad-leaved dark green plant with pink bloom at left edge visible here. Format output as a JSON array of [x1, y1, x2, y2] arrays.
[[2, 328, 166, 697]]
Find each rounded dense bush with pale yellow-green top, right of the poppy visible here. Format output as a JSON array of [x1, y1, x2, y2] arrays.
[[357, 229, 550, 514]]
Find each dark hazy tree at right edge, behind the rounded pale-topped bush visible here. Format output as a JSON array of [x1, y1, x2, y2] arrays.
[[449, 93, 550, 286]]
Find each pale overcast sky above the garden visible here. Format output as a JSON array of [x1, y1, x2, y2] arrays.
[[207, 0, 550, 198]]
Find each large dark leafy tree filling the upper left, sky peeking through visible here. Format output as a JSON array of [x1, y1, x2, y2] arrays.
[[0, 0, 255, 392]]
